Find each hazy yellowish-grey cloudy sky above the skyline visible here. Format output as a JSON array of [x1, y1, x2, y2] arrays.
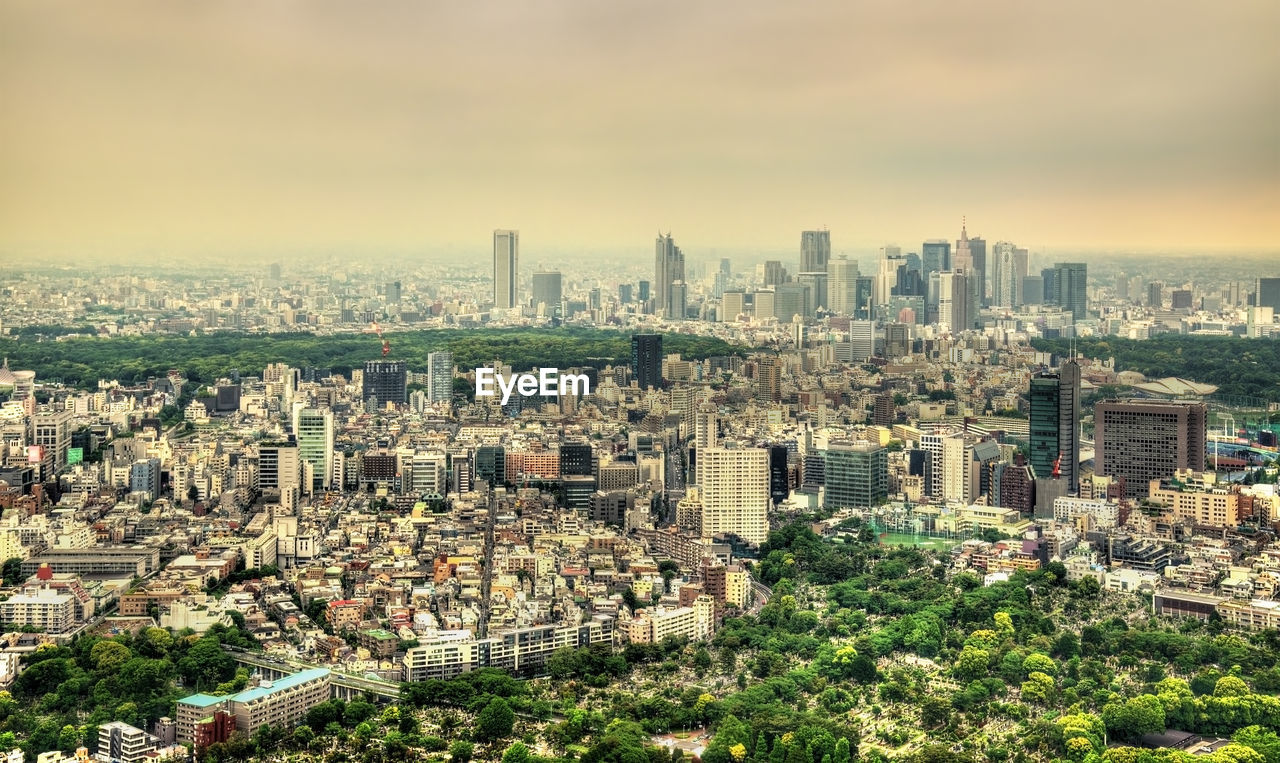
[[0, 0, 1280, 261]]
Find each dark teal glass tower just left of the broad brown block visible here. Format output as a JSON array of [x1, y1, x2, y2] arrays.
[[1027, 361, 1080, 493]]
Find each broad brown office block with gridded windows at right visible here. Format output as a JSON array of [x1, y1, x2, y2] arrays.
[[1093, 399, 1207, 498]]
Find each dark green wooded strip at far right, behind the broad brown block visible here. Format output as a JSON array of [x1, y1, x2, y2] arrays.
[[1032, 334, 1280, 402]]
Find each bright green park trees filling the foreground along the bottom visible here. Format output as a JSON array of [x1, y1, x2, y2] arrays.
[[0, 521, 1280, 763]]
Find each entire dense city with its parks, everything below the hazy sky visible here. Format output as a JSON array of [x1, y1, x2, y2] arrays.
[[0, 230, 1280, 763]]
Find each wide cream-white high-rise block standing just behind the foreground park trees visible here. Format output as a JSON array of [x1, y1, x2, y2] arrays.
[[698, 448, 769, 544]]
